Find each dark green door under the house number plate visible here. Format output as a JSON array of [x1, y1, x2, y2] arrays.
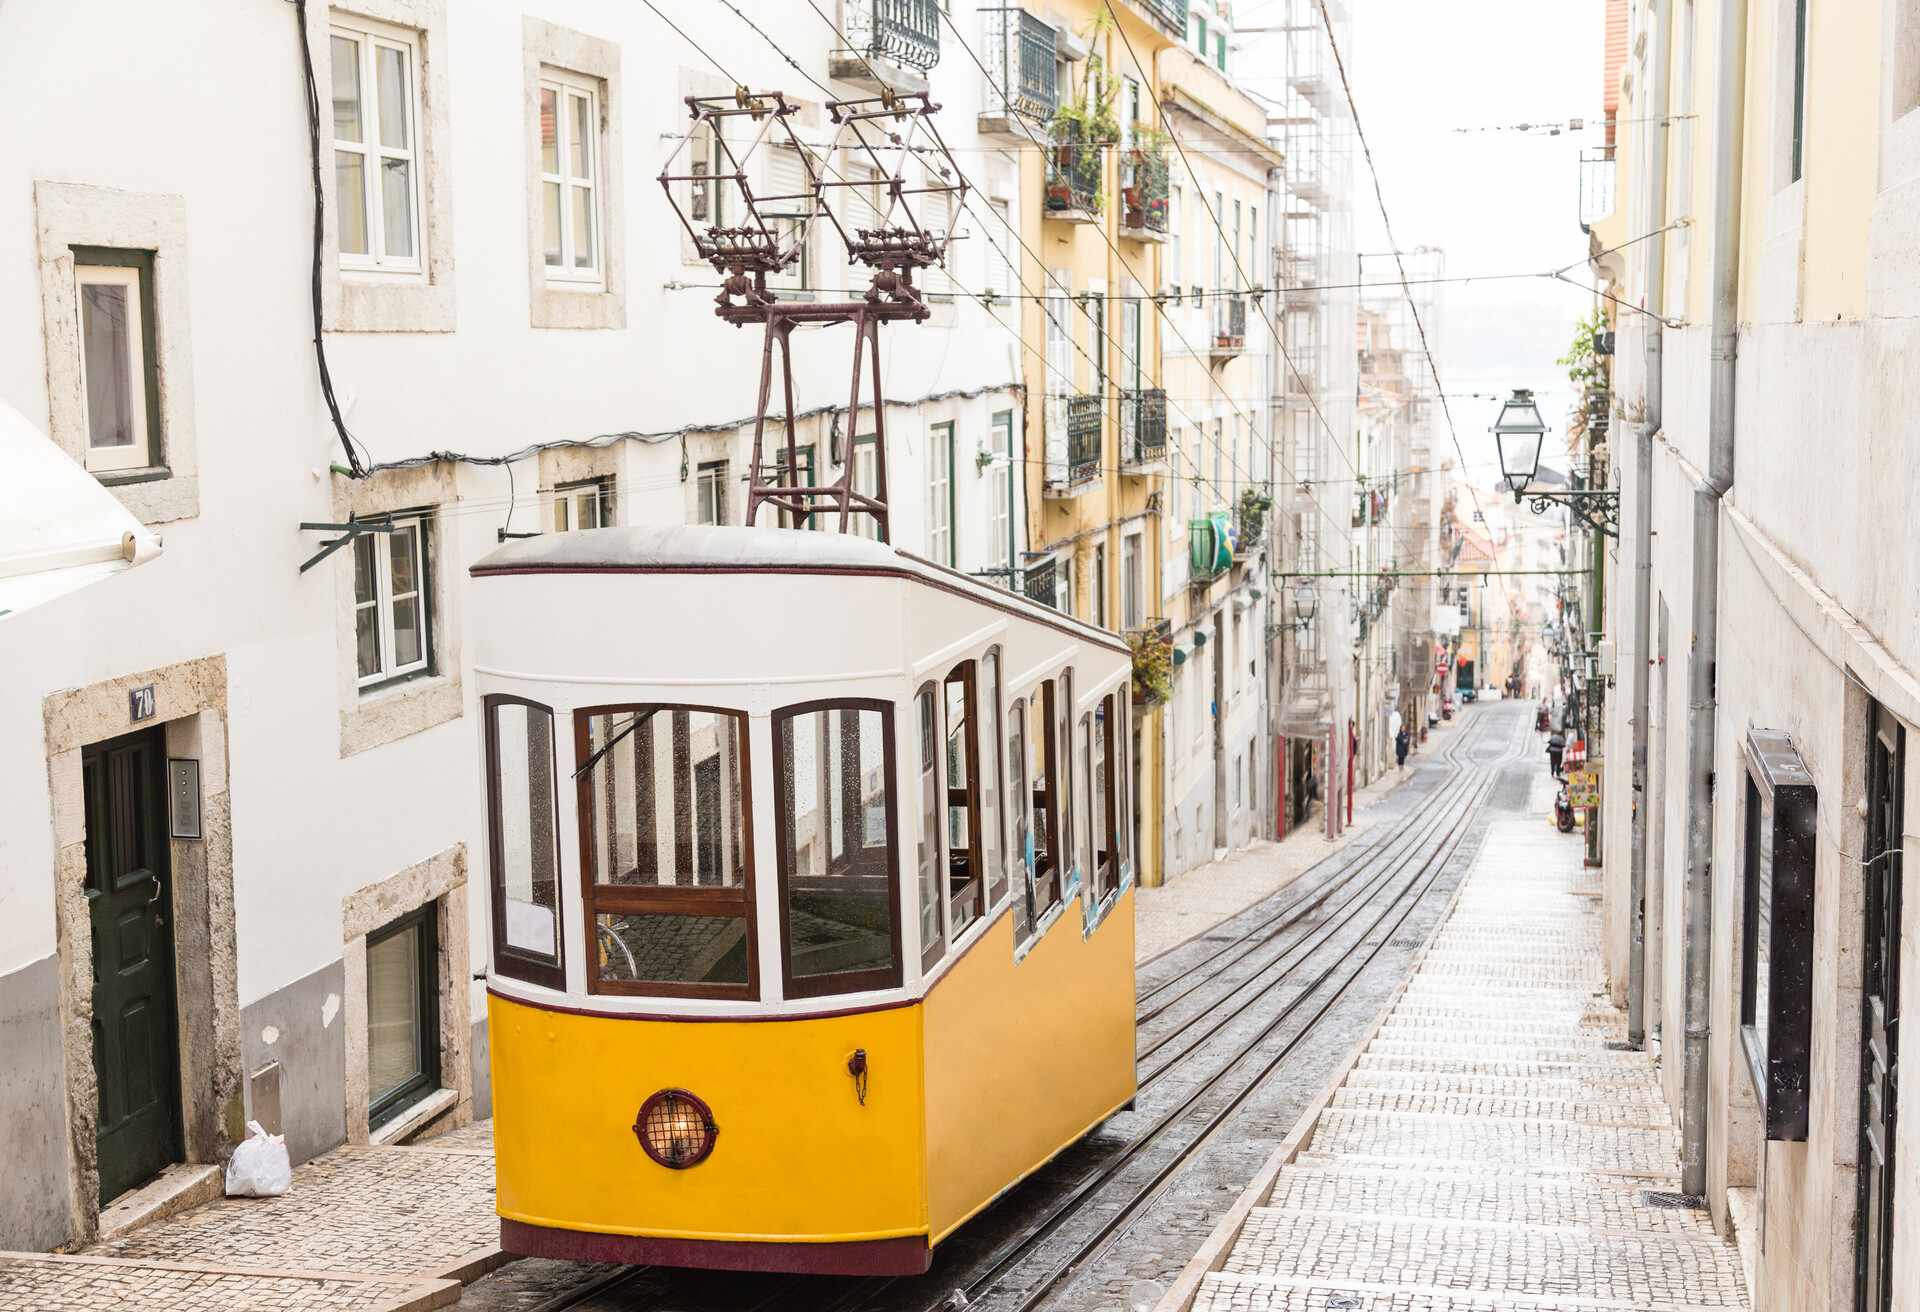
[[81, 730, 180, 1203]]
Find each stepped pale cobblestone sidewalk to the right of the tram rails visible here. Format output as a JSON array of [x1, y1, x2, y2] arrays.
[[1192, 814, 1747, 1312]]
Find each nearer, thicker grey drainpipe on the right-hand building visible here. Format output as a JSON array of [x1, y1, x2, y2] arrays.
[[1680, 0, 1747, 1197]]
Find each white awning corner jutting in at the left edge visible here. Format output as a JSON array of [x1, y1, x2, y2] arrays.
[[0, 401, 159, 620]]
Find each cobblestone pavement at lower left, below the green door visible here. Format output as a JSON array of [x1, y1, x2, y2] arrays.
[[0, 1122, 501, 1312]]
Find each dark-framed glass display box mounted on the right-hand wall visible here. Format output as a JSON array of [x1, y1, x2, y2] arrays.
[[1740, 730, 1818, 1141]]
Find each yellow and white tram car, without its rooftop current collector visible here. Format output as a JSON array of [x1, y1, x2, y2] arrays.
[[470, 526, 1135, 1274]]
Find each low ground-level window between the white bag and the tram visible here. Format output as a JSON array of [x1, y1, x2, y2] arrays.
[[367, 903, 439, 1130]]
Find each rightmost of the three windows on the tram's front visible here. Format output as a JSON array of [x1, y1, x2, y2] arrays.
[[774, 701, 900, 997]]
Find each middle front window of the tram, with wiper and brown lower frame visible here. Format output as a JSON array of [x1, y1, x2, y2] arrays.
[[574, 703, 756, 997]]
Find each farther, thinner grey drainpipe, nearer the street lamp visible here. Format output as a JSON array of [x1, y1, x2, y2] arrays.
[[1626, 0, 1674, 1049]]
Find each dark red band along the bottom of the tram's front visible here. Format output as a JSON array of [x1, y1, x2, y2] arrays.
[[499, 1216, 933, 1276]]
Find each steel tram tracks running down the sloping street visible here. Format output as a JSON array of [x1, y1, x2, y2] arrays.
[[514, 715, 1530, 1312]]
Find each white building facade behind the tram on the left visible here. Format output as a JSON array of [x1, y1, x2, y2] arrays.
[[0, 0, 1027, 1249]]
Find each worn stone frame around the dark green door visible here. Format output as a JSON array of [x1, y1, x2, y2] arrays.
[[40, 655, 246, 1243]]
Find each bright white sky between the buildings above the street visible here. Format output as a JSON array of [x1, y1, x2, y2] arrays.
[[1313, 0, 1603, 480]]
